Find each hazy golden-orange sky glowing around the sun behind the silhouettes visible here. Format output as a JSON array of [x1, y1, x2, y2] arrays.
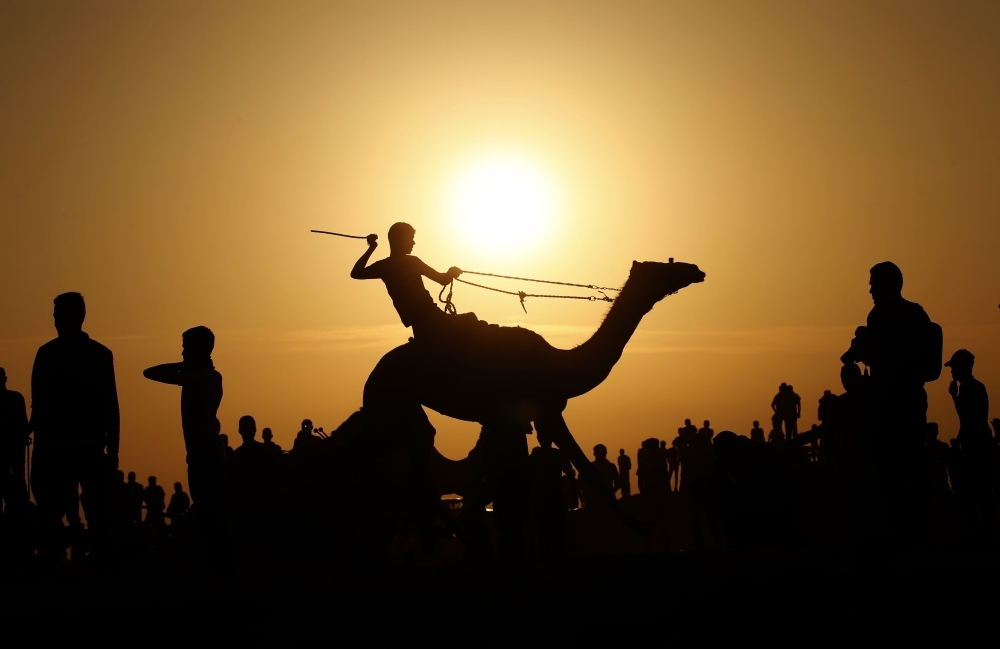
[[0, 0, 1000, 481]]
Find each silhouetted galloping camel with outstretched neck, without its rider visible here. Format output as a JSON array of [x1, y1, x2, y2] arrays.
[[363, 259, 705, 530]]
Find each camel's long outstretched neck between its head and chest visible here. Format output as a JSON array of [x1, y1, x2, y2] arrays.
[[560, 283, 656, 396]]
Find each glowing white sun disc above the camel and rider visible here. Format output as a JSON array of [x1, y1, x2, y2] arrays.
[[450, 156, 556, 257]]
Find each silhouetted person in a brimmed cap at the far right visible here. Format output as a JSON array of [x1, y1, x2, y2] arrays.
[[944, 349, 993, 539]]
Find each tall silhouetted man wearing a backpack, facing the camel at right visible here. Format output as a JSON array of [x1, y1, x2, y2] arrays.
[[841, 262, 942, 537]]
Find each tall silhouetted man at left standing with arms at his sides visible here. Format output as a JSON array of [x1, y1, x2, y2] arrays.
[[31, 293, 120, 563]]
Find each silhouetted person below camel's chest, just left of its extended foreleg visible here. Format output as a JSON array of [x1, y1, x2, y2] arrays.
[[528, 431, 576, 558]]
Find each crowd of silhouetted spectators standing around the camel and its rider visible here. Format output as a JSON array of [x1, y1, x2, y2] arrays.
[[0, 262, 1000, 565]]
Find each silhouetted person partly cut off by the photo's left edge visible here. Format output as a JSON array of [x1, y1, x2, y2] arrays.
[[0, 367, 31, 554]]
